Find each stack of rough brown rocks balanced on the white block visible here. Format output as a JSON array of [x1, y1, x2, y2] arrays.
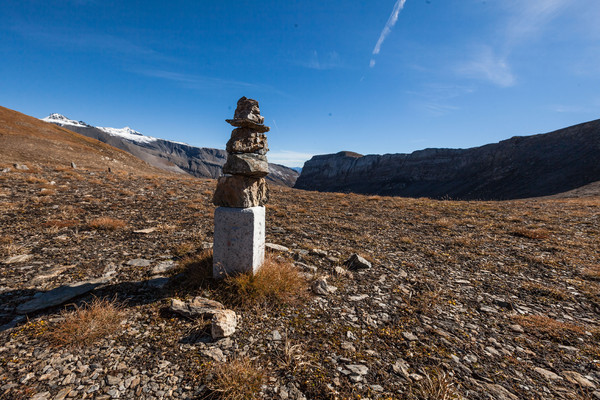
[[213, 97, 269, 208]]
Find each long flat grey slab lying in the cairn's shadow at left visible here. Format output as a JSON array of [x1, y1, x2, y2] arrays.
[[16, 277, 110, 314]]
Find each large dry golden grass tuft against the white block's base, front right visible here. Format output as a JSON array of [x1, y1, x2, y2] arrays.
[[225, 254, 308, 307]]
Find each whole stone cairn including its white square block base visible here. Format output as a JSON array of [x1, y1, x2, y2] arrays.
[[213, 97, 269, 278]]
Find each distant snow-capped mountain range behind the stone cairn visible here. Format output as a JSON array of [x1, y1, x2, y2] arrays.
[[42, 114, 299, 186]]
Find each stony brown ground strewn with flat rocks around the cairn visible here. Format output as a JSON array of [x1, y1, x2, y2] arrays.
[[0, 165, 600, 400]]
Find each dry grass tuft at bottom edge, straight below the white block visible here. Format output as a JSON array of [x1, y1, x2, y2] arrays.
[[208, 357, 266, 400]]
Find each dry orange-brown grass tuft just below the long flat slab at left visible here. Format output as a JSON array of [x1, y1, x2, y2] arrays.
[[46, 299, 125, 347]]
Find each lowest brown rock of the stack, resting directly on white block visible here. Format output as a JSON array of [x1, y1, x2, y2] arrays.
[[213, 175, 269, 208]]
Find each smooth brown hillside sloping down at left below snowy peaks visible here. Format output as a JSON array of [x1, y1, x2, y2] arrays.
[[0, 107, 171, 175]]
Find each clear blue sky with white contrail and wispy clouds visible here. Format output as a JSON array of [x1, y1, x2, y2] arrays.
[[0, 0, 600, 166]]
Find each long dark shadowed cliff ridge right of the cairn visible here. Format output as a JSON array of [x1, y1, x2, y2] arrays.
[[294, 120, 600, 200]]
